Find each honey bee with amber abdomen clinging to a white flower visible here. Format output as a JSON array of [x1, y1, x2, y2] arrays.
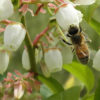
[[64, 26, 89, 64]]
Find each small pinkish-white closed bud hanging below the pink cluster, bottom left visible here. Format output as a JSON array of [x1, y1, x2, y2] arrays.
[[14, 84, 24, 99]]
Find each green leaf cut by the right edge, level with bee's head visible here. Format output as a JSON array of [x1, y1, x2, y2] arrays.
[[89, 18, 100, 35]]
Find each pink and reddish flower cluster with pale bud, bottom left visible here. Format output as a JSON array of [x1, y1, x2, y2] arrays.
[[0, 71, 40, 99]]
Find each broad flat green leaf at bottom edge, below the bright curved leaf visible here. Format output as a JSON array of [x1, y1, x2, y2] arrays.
[[45, 87, 80, 100]]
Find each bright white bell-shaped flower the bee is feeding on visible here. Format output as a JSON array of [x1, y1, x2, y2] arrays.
[[55, 4, 83, 31]]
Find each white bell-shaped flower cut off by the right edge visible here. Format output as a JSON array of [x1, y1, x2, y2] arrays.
[[93, 50, 100, 71]]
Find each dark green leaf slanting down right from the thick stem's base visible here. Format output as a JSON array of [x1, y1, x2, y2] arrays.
[[37, 75, 64, 93]]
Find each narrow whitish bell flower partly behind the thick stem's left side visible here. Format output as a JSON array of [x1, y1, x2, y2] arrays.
[[22, 49, 31, 70]]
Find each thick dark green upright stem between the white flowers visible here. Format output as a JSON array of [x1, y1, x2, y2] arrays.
[[21, 16, 37, 74]]
